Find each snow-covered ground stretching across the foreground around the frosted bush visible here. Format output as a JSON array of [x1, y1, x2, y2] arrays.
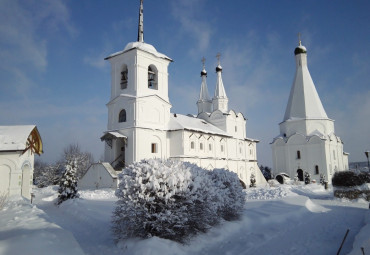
[[0, 184, 370, 255]]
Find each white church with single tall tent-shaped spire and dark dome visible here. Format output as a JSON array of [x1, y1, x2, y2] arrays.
[[271, 41, 348, 183]]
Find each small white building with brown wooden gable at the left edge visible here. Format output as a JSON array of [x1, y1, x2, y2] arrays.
[[0, 125, 42, 199]]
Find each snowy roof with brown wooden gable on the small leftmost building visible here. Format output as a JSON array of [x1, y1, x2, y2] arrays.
[[0, 125, 42, 154]]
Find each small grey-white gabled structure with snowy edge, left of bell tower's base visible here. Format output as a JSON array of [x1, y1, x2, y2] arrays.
[[78, 162, 118, 189]]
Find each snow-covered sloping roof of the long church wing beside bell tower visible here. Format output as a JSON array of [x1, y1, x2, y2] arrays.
[[168, 113, 230, 136]]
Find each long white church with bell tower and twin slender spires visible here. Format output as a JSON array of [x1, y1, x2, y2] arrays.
[[95, 1, 266, 185]]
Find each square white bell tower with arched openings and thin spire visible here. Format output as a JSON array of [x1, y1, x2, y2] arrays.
[[102, 0, 172, 167]]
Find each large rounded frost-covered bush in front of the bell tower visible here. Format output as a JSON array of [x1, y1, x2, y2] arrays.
[[112, 159, 245, 242]]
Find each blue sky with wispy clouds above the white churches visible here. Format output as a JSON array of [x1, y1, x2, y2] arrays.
[[0, 0, 370, 166]]
